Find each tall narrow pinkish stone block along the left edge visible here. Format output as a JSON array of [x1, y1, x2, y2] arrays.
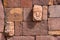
[[0, 0, 4, 32]]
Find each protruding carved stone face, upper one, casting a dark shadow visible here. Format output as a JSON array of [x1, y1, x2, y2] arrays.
[[33, 5, 42, 21]]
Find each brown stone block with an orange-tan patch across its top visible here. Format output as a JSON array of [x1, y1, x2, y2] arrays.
[[5, 8, 23, 21]]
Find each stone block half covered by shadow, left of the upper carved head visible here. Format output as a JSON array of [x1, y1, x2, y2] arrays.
[[24, 8, 33, 21]]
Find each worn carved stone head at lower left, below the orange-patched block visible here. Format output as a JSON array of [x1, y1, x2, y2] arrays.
[[5, 22, 14, 36]]
